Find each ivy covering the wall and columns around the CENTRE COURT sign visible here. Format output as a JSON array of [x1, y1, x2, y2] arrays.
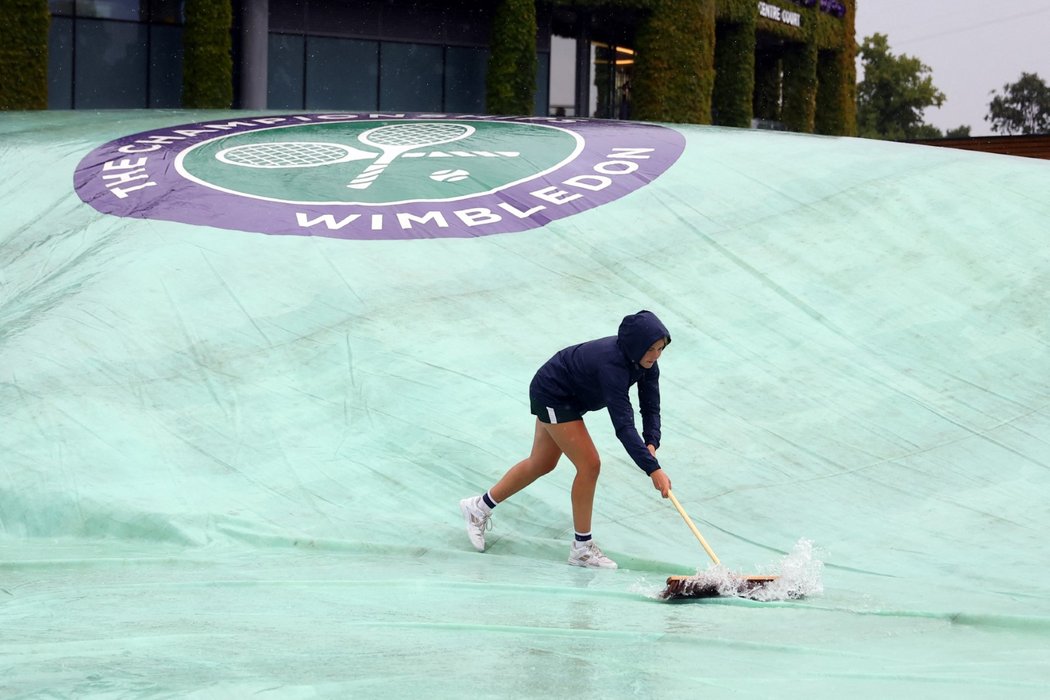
[[550, 0, 857, 135]]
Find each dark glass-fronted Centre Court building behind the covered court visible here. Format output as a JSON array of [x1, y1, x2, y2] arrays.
[[34, 0, 856, 134]]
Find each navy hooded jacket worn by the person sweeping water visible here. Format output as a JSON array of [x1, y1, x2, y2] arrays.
[[529, 311, 671, 474]]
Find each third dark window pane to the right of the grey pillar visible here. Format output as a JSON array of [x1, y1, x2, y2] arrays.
[[379, 43, 443, 111]]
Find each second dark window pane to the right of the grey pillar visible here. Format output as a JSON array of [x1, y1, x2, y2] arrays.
[[307, 37, 379, 111]]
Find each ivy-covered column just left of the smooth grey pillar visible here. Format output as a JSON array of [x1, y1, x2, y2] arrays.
[[183, 0, 233, 109]]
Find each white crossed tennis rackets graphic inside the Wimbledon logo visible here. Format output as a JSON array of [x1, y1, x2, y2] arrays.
[[215, 122, 517, 190]]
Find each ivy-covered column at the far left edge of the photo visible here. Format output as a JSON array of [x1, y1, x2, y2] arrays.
[[0, 0, 50, 109]]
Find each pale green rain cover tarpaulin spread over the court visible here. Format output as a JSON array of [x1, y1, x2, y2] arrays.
[[0, 111, 1050, 698]]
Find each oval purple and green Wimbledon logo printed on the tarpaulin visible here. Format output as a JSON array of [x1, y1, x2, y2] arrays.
[[74, 113, 685, 239]]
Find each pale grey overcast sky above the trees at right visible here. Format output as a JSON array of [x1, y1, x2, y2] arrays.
[[857, 0, 1050, 136]]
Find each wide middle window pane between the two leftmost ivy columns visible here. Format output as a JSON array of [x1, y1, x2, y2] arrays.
[[74, 20, 149, 109]]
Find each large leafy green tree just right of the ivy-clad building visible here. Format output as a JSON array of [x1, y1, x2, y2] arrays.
[[857, 34, 945, 140]]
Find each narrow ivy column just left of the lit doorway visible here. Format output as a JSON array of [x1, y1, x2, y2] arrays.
[[485, 0, 537, 114]]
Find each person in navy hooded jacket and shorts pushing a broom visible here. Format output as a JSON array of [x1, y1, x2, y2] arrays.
[[460, 311, 671, 569]]
